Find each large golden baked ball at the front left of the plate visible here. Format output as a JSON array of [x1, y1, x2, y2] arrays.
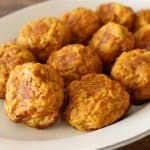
[[5, 63, 64, 129]]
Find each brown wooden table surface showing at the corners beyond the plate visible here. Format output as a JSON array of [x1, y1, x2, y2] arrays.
[[0, 0, 150, 150]]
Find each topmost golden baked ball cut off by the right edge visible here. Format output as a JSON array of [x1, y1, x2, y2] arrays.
[[135, 9, 150, 30]]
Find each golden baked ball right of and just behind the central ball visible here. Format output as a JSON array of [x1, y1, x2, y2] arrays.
[[90, 22, 135, 71]]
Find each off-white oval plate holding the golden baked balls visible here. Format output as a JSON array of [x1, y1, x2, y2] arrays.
[[0, 0, 150, 150]]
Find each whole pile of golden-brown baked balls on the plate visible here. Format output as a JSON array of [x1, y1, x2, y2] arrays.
[[0, 3, 150, 131]]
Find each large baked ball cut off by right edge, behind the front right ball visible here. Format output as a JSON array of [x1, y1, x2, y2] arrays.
[[111, 49, 150, 102]]
